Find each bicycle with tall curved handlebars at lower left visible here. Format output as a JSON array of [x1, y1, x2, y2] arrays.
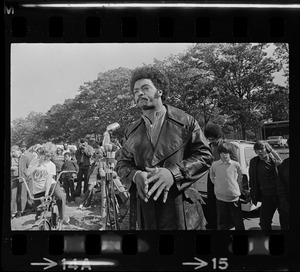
[[16, 171, 76, 231]]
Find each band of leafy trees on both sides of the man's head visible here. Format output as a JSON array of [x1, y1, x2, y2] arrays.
[[11, 43, 289, 145]]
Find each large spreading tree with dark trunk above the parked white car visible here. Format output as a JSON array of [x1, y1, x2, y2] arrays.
[[186, 43, 280, 139]]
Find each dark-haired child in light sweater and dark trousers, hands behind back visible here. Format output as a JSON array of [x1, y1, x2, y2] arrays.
[[210, 142, 245, 230]]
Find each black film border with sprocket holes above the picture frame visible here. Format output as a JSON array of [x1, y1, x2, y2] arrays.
[[6, 8, 299, 42]]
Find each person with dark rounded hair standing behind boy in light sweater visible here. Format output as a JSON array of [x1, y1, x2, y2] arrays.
[[203, 123, 238, 230]]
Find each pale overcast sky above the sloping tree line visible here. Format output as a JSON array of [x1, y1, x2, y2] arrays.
[[11, 43, 284, 120]]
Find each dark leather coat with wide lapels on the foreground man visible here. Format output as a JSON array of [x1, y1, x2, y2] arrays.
[[116, 105, 213, 230]]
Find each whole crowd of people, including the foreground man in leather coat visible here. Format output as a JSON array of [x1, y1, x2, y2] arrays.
[[11, 66, 289, 230]]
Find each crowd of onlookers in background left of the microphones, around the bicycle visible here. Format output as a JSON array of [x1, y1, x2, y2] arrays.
[[11, 138, 129, 229]]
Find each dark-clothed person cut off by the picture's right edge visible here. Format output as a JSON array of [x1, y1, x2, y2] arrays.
[[278, 140, 290, 230]]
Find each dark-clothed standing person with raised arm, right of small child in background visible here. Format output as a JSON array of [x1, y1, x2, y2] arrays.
[[74, 138, 94, 196]]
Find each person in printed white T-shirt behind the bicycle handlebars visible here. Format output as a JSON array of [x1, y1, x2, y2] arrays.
[[26, 143, 69, 223]]
